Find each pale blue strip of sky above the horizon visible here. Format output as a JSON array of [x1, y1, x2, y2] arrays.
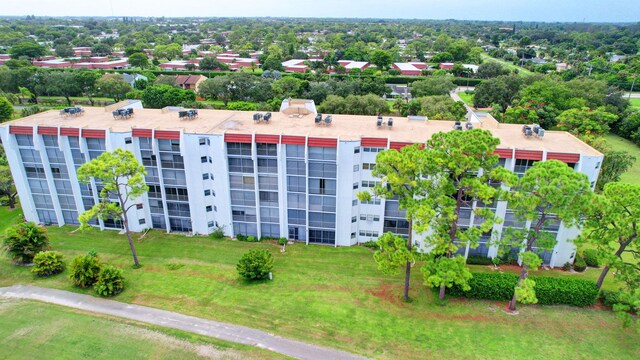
[[0, 0, 640, 22]]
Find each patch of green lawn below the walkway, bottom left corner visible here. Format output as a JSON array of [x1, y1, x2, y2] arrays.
[[0, 299, 282, 360]]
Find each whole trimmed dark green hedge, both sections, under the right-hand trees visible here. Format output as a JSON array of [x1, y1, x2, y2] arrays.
[[448, 273, 598, 307]]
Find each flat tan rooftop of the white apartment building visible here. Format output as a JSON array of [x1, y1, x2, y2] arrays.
[[0, 105, 601, 156]]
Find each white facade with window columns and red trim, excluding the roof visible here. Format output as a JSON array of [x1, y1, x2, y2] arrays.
[[0, 125, 603, 266]]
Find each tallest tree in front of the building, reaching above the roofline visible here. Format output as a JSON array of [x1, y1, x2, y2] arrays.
[[419, 129, 516, 300]]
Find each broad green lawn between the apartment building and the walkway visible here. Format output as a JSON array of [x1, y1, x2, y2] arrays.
[[0, 205, 640, 359]]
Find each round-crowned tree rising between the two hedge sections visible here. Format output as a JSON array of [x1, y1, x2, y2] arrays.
[[502, 160, 592, 311]]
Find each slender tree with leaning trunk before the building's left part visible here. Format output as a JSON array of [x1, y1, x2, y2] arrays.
[[78, 149, 149, 266]]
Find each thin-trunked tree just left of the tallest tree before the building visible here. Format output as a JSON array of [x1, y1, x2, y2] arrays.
[[358, 145, 431, 301]]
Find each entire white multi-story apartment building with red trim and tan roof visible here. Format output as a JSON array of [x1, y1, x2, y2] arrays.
[[0, 100, 603, 266]]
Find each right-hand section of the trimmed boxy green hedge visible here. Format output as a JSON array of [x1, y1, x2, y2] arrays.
[[534, 276, 598, 307]]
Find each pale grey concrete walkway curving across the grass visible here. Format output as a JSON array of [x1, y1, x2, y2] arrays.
[[0, 285, 364, 360]]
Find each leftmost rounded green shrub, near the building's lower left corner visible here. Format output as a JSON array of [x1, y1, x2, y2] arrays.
[[2, 222, 49, 264]]
